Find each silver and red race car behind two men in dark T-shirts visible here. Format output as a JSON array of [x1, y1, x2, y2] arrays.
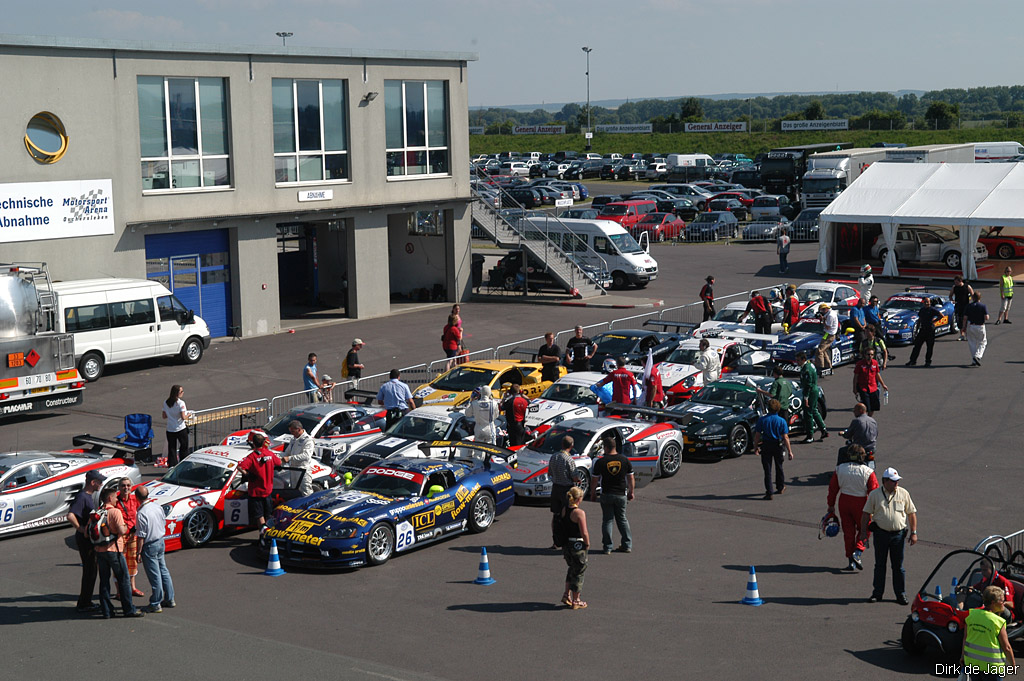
[[512, 418, 671, 499]]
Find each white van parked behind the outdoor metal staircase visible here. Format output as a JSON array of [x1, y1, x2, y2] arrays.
[[529, 217, 657, 289]]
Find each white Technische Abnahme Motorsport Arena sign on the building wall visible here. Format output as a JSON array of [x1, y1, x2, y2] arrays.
[[0, 179, 114, 243]]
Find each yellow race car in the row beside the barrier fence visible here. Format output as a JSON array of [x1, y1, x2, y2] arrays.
[[413, 359, 566, 407]]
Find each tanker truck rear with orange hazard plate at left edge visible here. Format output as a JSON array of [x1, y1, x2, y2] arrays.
[[0, 262, 85, 419]]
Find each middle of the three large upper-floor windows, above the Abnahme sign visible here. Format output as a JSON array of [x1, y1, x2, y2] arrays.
[[270, 78, 349, 184]]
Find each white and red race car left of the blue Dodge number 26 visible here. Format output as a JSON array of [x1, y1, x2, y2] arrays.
[[145, 444, 338, 551]]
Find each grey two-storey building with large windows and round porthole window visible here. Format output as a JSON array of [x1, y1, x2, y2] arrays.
[[0, 36, 476, 337]]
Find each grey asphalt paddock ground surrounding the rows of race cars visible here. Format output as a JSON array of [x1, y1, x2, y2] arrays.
[[0, 220, 1024, 680]]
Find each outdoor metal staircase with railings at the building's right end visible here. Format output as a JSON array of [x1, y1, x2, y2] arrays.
[[472, 189, 608, 298]]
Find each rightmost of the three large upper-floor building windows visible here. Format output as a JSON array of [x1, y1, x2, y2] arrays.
[[384, 81, 451, 177]]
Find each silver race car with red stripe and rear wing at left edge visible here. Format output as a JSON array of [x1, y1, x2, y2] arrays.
[[0, 435, 142, 537]]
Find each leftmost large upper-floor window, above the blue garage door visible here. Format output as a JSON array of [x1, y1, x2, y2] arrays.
[[138, 76, 231, 191]]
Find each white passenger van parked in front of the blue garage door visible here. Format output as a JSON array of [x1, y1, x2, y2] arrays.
[[52, 279, 210, 381]]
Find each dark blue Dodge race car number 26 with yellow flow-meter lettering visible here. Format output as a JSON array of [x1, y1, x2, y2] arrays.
[[260, 440, 515, 567]]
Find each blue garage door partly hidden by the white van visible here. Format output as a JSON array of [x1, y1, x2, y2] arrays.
[[145, 229, 232, 338]]
